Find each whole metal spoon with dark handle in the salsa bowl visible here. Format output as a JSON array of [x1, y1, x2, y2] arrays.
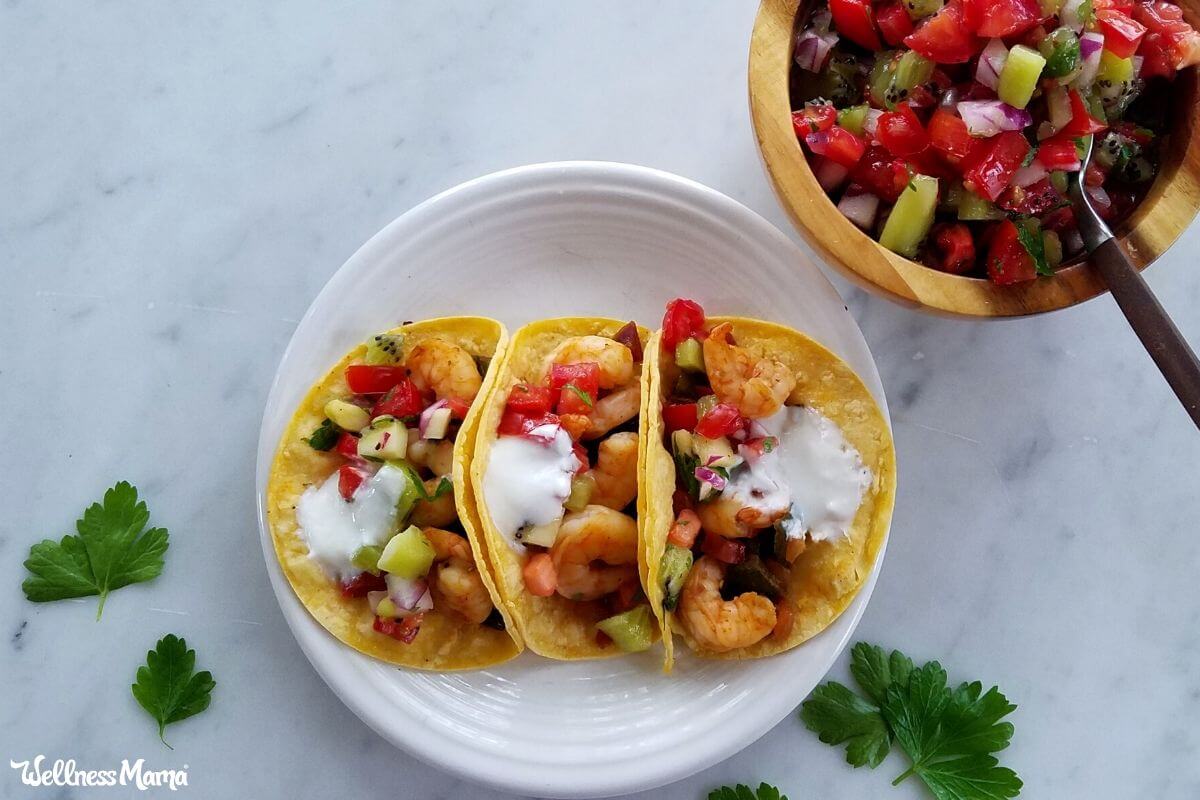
[[1068, 136, 1200, 427]]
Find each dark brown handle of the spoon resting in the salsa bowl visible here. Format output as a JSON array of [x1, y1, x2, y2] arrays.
[[1088, 239, 1200, 427]]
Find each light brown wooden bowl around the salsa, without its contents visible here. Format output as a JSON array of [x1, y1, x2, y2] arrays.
[[750, 0, 1200, 317]]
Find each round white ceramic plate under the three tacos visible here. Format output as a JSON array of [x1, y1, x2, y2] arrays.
[[257, 162, 887, 798]]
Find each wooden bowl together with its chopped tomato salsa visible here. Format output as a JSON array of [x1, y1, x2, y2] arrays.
[[750, 0, 1200, 315]]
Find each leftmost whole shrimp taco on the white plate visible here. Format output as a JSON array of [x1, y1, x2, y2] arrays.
[[268, 317, 521, 670]]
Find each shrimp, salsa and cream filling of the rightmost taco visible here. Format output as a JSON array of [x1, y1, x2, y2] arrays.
[[655, 300, 892, 663]]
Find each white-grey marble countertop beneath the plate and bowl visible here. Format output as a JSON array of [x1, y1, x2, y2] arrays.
[[0, 0, 1200, 800]]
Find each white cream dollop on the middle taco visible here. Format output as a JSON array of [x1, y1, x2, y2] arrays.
[[484, 425, 580, 553]]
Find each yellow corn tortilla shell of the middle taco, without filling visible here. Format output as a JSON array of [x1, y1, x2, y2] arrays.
[[470, 318, 649, 661]]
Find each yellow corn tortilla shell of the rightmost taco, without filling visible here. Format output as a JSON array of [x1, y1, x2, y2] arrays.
[[642, 317, 896, 672]]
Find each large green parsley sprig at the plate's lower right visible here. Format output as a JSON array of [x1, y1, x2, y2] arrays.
[[800, 643, 1022, 800]]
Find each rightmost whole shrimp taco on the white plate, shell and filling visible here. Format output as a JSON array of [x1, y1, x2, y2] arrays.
[[643, 300, 895, 670]]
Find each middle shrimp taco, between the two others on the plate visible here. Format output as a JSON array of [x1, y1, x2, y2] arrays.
[[470, 318, 658, 660]]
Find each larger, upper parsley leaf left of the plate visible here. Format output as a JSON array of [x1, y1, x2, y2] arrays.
[[20, 481, 168, 619]]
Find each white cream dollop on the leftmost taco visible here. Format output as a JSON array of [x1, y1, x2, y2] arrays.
[[296, 464, 408, 581]]
